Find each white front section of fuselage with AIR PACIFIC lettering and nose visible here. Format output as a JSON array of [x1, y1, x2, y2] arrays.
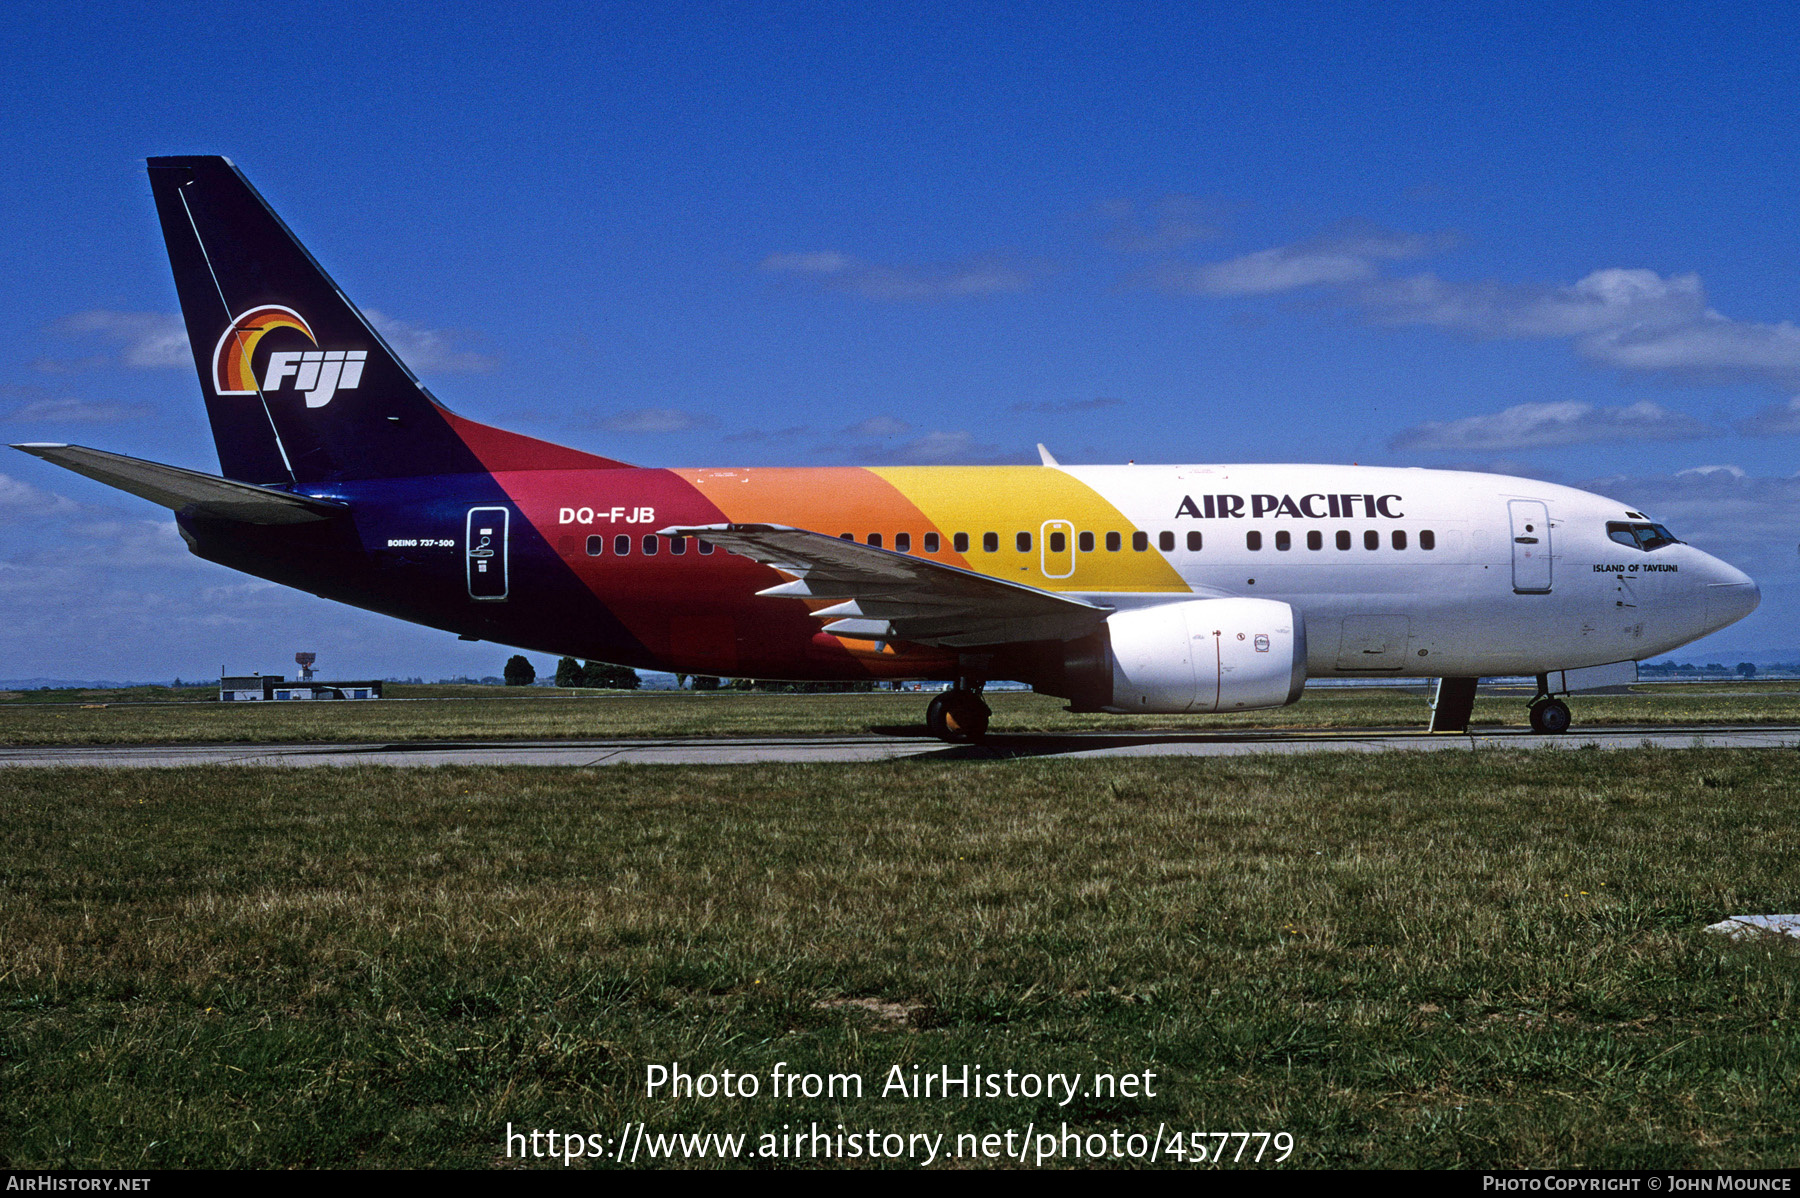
[[1064, 466, 1760, 678]]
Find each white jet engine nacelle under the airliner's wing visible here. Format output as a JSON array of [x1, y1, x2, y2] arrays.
[[1064, 599, 1307, 714]]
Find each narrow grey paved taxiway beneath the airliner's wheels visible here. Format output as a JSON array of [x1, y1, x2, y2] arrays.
[[0, 725, 1800, 768]]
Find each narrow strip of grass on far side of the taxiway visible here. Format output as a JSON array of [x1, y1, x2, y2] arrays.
[[0, 682, 1800, 745]]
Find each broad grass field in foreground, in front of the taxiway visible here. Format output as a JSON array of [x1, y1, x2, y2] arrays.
[[0, 751, 1800, 1169]]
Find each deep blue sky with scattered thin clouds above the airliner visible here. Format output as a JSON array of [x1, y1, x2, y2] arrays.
[[0, 4, 1800, 678]]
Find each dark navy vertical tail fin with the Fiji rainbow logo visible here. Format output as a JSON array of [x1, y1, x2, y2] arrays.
[[149, 156, 621, 484]]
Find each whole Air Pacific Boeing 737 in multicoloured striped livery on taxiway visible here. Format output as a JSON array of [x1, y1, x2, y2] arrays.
[[14, 156, 1760, 741]]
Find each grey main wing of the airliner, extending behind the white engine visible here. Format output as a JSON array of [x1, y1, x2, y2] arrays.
[[661, 523, 1112, 648]]
